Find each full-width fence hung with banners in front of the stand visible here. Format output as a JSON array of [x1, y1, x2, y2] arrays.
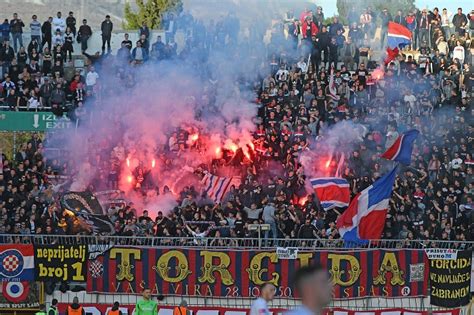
[[0, 235, 472, 315]]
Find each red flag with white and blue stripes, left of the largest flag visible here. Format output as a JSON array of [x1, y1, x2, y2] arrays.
[[310, 177, 351, 211]]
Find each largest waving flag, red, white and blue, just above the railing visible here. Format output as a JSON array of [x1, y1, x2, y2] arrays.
[[337, 166, 397, 243]]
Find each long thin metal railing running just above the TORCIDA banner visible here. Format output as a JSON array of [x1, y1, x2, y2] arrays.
[[0, 234, 474, 250]]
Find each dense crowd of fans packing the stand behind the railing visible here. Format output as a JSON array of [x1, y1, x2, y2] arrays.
[[0, 7, 474, 247]]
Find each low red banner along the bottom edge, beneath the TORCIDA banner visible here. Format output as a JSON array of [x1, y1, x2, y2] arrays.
[[55, 303, 460, 315]]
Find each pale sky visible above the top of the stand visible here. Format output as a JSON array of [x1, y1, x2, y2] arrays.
[[316, 0, 474, 16]]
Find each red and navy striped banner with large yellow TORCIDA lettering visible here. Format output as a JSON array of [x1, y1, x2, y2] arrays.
[[87, 247, 428, 298]]
